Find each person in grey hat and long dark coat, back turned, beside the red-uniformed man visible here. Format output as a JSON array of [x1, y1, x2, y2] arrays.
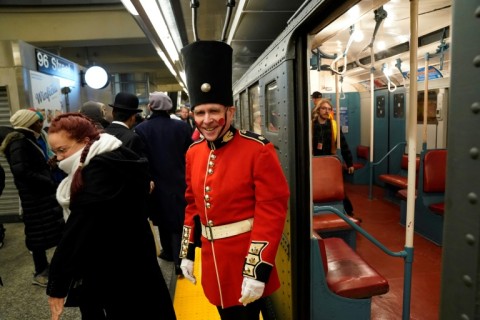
[[135, 92, 192, 275]]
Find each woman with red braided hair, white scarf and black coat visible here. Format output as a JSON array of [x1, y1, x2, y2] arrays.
[[47, 113, 176, 320]]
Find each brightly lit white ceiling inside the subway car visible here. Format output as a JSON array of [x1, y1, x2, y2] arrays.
[[310, 0, 452, 91]]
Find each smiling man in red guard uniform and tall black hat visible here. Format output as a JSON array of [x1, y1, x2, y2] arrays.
[[180, 41, 290, 320]]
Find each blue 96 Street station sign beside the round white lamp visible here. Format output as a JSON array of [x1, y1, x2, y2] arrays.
[[35, 49, 78, 80]]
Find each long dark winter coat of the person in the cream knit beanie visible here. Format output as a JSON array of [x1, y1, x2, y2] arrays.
[[0, 129, 64, 250]]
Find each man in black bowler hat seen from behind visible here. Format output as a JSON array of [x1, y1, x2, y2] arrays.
[[105, 92, 145, 157]]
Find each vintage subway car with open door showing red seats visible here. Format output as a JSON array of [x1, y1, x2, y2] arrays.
[[223, 0, 480, 319]]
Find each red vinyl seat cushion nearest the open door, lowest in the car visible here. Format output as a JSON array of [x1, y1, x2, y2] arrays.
[[316, 235, 389, 299]]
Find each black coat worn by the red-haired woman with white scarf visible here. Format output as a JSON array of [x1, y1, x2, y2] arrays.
[[47, 146, 175, 319]]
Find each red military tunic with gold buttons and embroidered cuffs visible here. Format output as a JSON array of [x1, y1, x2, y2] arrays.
[[181, 127, 290, 308]]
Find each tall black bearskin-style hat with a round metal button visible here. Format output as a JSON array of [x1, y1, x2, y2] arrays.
[[182, 41, 233, 110]]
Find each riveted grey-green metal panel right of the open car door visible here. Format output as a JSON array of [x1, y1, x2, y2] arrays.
[[440, 0, 480, 320]]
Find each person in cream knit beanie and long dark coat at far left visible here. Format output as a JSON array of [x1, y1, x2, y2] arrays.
[[0, 109, 64, 286]]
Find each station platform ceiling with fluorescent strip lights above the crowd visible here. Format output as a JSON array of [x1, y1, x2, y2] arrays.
[[0, 0, 304, 91]]
